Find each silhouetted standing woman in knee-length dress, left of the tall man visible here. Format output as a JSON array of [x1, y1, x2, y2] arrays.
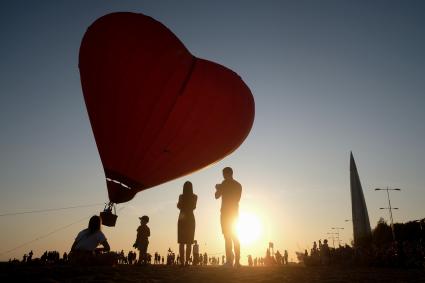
[[177, 181, 198, 265]]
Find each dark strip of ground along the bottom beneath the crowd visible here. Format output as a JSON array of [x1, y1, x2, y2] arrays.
[[0, 263, 425, 283]]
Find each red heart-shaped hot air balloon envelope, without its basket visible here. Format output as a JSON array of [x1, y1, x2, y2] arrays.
[[79, 13, 254, 203]]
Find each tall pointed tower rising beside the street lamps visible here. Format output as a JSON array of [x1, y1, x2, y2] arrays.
[[350, 152, 372, 246]]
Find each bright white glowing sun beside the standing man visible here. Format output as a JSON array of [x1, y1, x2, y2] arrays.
[[235, 212, 263, 245]]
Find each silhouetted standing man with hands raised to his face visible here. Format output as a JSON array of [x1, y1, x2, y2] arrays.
[[215, 167, 242, 267]]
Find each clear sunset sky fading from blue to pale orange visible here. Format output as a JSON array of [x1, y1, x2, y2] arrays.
[[0, 1, 425, 261]]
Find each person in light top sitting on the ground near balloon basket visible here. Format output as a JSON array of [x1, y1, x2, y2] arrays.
[[71, 215, 111, 253]]
